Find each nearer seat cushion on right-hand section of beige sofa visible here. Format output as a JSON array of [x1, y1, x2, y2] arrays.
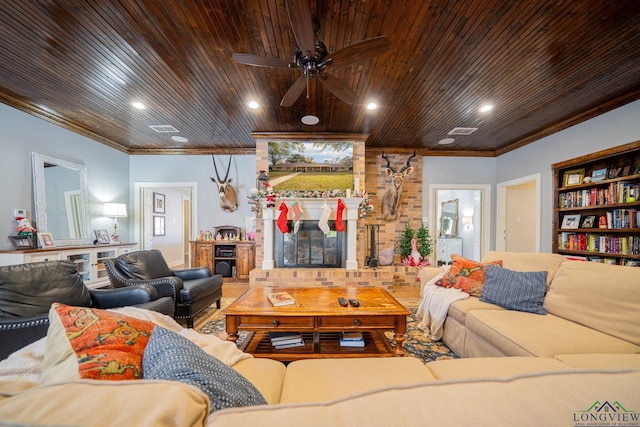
[[465, 310, 640, 357]]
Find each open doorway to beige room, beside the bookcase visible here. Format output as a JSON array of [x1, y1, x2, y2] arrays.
[[496, 174, 541, 252]]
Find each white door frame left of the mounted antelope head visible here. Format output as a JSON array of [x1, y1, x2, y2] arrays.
[[133, 181, 199, 258]]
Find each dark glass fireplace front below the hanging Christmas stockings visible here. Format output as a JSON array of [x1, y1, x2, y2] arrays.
[[274, 221, 345, 268]]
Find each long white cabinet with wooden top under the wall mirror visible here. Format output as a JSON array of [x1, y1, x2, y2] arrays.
[[0, 243, 136, 288]]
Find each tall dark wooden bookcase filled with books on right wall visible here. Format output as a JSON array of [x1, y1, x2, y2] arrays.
[[552, 141, 640, 267]]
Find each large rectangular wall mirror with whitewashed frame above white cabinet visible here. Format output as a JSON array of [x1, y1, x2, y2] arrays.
[[32, 153, 91, 246]]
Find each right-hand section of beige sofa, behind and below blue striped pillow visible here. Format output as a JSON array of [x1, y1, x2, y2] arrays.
[[420, 252, 640, 358]]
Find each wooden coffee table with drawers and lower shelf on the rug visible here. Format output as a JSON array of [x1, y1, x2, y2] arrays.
[[223, 287, 410, 361]]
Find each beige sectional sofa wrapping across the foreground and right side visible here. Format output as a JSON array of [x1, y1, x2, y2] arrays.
[[0, 253, 640, 426]]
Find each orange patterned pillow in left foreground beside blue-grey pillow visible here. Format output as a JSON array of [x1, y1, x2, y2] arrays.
[[52, 303, 156, 380]]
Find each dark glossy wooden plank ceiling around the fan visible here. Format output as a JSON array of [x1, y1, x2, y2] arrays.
[[0, 0, 640, 156]]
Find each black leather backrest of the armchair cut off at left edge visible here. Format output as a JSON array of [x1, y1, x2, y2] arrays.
[[0, 261, 91, 317]]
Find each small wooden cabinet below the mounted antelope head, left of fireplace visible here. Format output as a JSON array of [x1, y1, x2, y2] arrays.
[[189, 240, 255, 280]]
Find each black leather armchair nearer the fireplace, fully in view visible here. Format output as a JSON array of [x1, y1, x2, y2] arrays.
[[105, 249, 222, 328]]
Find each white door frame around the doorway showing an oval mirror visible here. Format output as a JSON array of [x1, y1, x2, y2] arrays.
[[428, 184, 491, 266]]
